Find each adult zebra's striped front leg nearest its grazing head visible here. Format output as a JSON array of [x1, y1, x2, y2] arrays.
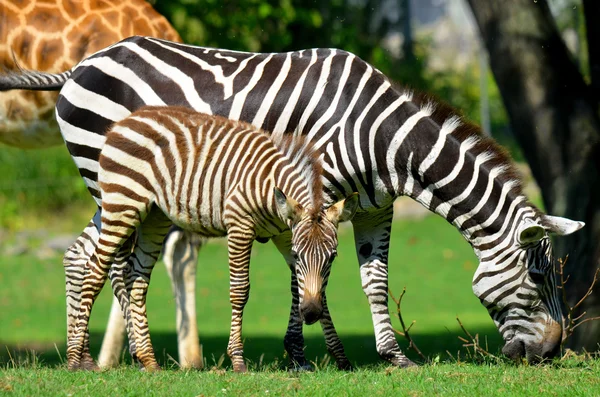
[[352, 205, 415, 367]]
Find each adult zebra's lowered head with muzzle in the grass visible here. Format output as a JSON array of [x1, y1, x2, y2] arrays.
[[473, 213, 584, 363]]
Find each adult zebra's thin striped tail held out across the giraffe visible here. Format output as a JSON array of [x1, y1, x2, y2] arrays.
[[0, 69, 72, 91]]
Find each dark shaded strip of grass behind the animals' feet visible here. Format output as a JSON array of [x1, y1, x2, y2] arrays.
[[0, 327, 502, 367]]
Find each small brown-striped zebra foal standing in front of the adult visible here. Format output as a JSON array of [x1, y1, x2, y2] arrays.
[[67, 107, 358, 372]]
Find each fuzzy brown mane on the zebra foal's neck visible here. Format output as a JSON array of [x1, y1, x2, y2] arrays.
[[269, 134, 324, 215]]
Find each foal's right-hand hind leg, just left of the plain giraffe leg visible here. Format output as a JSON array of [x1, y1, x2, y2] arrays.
[[127, 207, 173, 371]]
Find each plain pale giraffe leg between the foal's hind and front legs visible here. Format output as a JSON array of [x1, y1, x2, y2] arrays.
[[163, 228, 205, 369]]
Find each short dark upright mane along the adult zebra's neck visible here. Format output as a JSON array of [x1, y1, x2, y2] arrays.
[[408, 85, 537, 204]]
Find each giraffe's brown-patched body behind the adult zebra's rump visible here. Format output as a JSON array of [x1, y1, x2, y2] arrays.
[[0, 0, 181, 148]]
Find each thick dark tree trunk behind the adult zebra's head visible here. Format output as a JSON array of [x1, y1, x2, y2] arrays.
[[468, 0, 600, 351]]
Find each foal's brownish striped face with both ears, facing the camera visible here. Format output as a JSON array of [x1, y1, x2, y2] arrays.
[[275, 188, 358, 324]]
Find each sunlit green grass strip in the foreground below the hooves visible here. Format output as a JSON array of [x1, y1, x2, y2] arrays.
[[0, 361, 600, 396]]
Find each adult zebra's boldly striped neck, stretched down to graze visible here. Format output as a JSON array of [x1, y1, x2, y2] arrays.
[[386, 105, 529, 244]]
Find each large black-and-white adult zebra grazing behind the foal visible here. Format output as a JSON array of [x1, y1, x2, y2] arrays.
[[0, 37, 583, 366]]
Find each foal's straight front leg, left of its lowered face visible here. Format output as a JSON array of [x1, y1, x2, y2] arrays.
[[227, 228, 254, 372]]
